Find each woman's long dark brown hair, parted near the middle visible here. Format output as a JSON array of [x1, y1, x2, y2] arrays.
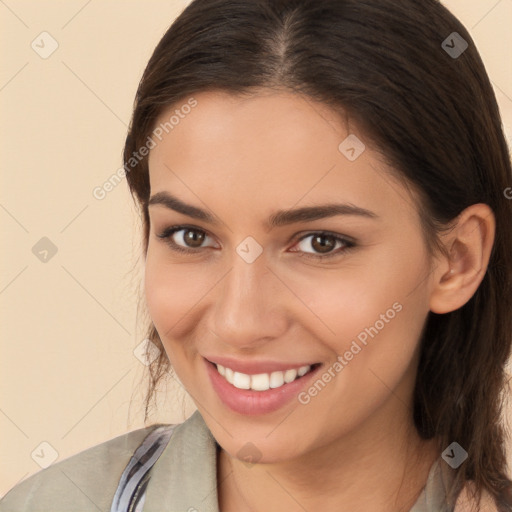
[[124, 0, 512, 510]]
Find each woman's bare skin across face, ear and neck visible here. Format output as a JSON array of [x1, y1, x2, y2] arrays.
[[145, 90, 495, 512]]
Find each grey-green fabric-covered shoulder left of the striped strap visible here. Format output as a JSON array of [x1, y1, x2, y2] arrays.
[[0, 425, 164, 512]]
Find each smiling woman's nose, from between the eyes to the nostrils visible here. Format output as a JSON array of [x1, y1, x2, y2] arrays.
[[210, 253, 290, 350]]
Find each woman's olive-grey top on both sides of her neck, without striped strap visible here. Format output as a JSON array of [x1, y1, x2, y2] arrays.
[[0, 411, 453, 512]]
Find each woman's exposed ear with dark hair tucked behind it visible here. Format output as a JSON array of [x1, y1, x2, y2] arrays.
[[429, 203, 496, 313]]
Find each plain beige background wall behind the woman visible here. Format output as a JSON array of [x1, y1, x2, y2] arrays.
[[0, 0, 512, 496]]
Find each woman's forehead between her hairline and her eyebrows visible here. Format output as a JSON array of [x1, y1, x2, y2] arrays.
[[149, 91, 418, 224]]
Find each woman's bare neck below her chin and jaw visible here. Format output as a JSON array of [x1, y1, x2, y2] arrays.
[[217, 399, 439, 512]]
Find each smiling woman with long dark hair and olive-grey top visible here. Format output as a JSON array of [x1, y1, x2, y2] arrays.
[[0, 0, 512, 512]]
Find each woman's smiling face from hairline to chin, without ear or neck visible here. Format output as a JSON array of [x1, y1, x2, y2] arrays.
[[145, 91, 438, 462]]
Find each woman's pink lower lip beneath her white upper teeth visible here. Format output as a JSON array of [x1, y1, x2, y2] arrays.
[[204, 359, 321, 415]]
